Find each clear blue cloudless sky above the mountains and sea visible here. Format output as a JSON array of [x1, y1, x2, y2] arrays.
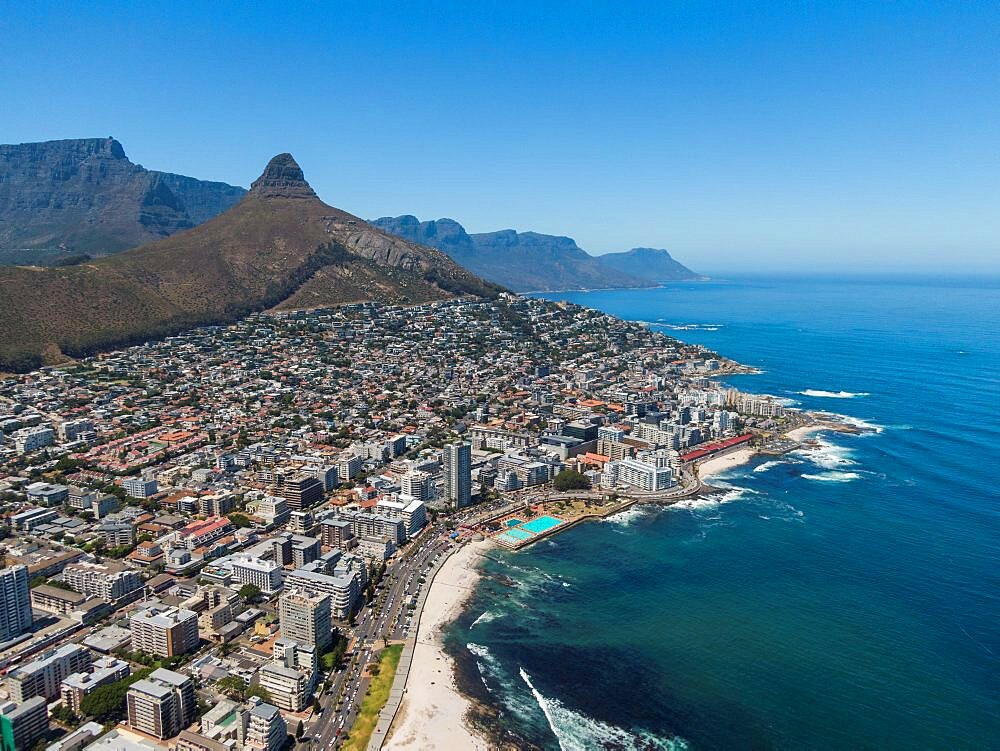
[[0, 0, 1000, 274]]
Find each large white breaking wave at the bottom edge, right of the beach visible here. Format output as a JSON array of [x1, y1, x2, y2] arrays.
[[519, 668, 687, 751]]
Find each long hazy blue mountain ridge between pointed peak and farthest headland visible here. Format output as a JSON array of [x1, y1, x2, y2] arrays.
[[372, 216, 653, 292]]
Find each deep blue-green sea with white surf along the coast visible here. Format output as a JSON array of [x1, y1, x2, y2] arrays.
[[447, 278, 1000, 751]]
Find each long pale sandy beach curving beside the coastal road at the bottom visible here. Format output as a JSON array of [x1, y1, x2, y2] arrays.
[[383, 542, 490, 751]]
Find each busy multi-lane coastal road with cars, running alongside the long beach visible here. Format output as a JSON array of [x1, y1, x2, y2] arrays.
[[302, 524, 454, 751]]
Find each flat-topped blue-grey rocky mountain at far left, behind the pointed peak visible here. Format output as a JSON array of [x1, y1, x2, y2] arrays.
[[0, 138, 246, 263]]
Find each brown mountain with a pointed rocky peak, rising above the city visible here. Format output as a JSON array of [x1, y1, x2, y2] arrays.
[[0, 154, 501, 370]]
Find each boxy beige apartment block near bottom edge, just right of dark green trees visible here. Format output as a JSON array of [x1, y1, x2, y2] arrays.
[[127, 668, 195, 739]]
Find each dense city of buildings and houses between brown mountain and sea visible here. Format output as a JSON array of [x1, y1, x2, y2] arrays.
[[0, 293, 797, 751]]
